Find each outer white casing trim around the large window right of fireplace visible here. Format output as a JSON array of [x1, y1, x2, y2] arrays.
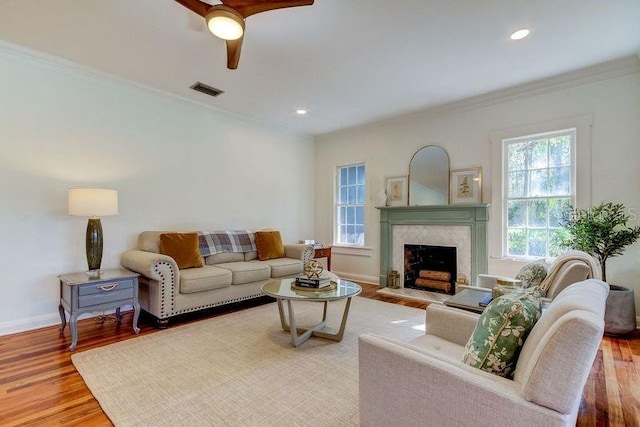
[[484, 114, 593, 260]]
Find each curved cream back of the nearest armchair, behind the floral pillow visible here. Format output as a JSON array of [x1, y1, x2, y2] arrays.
[[514, 279, 609, 414]]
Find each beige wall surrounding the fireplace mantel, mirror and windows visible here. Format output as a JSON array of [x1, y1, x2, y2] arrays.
[[315, 59, 640, 312]]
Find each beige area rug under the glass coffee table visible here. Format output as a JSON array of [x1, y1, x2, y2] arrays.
[[72, 297, 425, 426]]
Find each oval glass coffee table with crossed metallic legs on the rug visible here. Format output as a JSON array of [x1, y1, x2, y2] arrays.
[[262, 278, 362, 347]]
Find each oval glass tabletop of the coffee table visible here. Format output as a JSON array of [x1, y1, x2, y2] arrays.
[[262, 278, 362, 301]]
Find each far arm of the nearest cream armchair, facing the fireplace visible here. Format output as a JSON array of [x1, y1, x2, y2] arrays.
[[425, 304, 480, 346]]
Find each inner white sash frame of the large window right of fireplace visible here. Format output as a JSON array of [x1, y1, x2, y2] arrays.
[[502, 128, 577, 260]]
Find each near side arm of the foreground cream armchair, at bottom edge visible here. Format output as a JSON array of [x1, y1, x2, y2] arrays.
[[358, 334, 571, 427]]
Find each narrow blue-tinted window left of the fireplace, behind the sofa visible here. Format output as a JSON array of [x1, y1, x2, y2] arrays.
[[336, 163, 365, 245]]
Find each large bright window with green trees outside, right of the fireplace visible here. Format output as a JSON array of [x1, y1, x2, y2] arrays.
[[502, 129, 576, 257]]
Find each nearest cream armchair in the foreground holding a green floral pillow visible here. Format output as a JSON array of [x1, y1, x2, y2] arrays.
[[359, 280, 609, 427]]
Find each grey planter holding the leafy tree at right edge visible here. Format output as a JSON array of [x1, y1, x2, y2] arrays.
[[604, 285, 636, 335]]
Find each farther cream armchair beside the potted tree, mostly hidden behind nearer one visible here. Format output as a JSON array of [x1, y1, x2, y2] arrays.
[[474, 250, 602, 299]]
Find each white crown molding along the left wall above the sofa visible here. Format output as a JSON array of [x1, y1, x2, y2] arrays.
[[0, 40, 312, 139]]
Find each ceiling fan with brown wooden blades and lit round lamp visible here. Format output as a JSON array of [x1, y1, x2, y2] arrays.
[[175, 0, 313, 70]]
